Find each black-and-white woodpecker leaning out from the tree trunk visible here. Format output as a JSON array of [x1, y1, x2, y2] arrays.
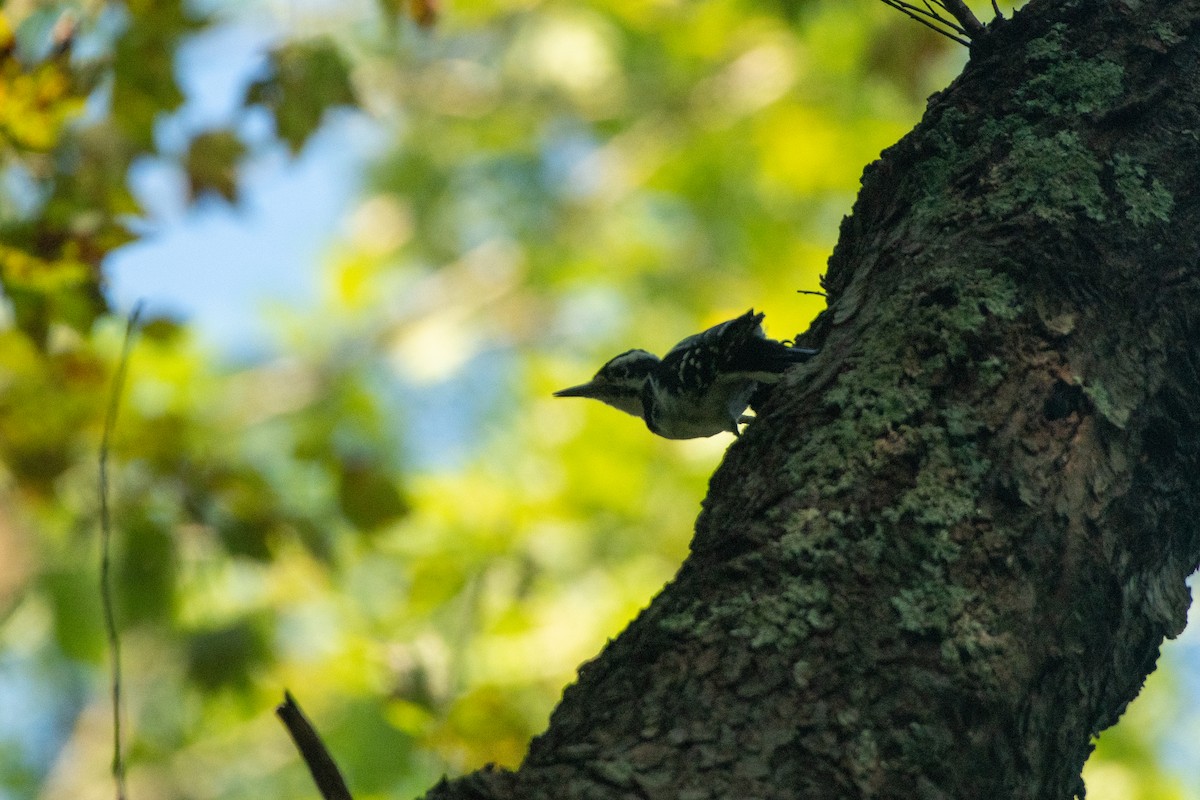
[[554, 308, 817, 439]]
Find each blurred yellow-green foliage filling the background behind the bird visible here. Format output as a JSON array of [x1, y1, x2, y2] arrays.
[[0, 0, 1183, 800]]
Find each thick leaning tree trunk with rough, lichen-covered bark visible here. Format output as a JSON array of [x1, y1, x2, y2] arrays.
[[428, 0, 1200, 800]]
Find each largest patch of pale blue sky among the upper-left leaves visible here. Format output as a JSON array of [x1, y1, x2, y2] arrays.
[[104, 23, 382, 355]]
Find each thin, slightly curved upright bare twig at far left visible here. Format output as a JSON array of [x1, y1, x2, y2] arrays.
[[100, 302, 142, 800]]
